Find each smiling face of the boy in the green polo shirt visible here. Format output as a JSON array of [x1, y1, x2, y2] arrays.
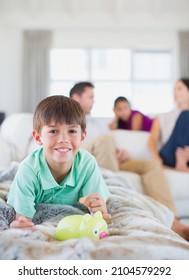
[[33, 123, 86, 168]]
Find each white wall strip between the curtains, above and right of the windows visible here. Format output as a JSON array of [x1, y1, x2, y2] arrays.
[[53, 29, 179, 80]]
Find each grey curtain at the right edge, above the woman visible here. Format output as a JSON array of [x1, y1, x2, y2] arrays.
[[179, 31, 189, 78]]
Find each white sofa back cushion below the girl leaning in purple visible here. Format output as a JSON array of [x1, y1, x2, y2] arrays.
[[110, 129, 151, 159]]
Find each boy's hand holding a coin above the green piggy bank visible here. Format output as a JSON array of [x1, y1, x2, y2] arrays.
[[79, 193, 111, 220]]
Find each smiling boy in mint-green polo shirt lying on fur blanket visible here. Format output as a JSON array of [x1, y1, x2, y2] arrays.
[[7, 96, 110, 229]]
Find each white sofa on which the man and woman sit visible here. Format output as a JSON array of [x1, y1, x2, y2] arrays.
[[0, 113, 189, 224]]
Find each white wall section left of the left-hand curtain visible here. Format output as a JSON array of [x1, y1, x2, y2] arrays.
[[0, 28, 22, 114]]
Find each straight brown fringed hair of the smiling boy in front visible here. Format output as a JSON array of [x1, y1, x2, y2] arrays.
[[33, 95, 86, 132]]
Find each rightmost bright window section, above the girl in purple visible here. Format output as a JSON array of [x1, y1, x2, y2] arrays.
[[132, 51, 173, 115]]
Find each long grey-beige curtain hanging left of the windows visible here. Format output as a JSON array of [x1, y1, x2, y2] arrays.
[[22, 31, 51, 113]]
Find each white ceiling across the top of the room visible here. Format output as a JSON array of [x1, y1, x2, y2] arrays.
[[0, 0, 189, 28]]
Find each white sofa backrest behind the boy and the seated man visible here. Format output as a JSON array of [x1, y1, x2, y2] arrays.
[[0, 113, 150, 167]]
